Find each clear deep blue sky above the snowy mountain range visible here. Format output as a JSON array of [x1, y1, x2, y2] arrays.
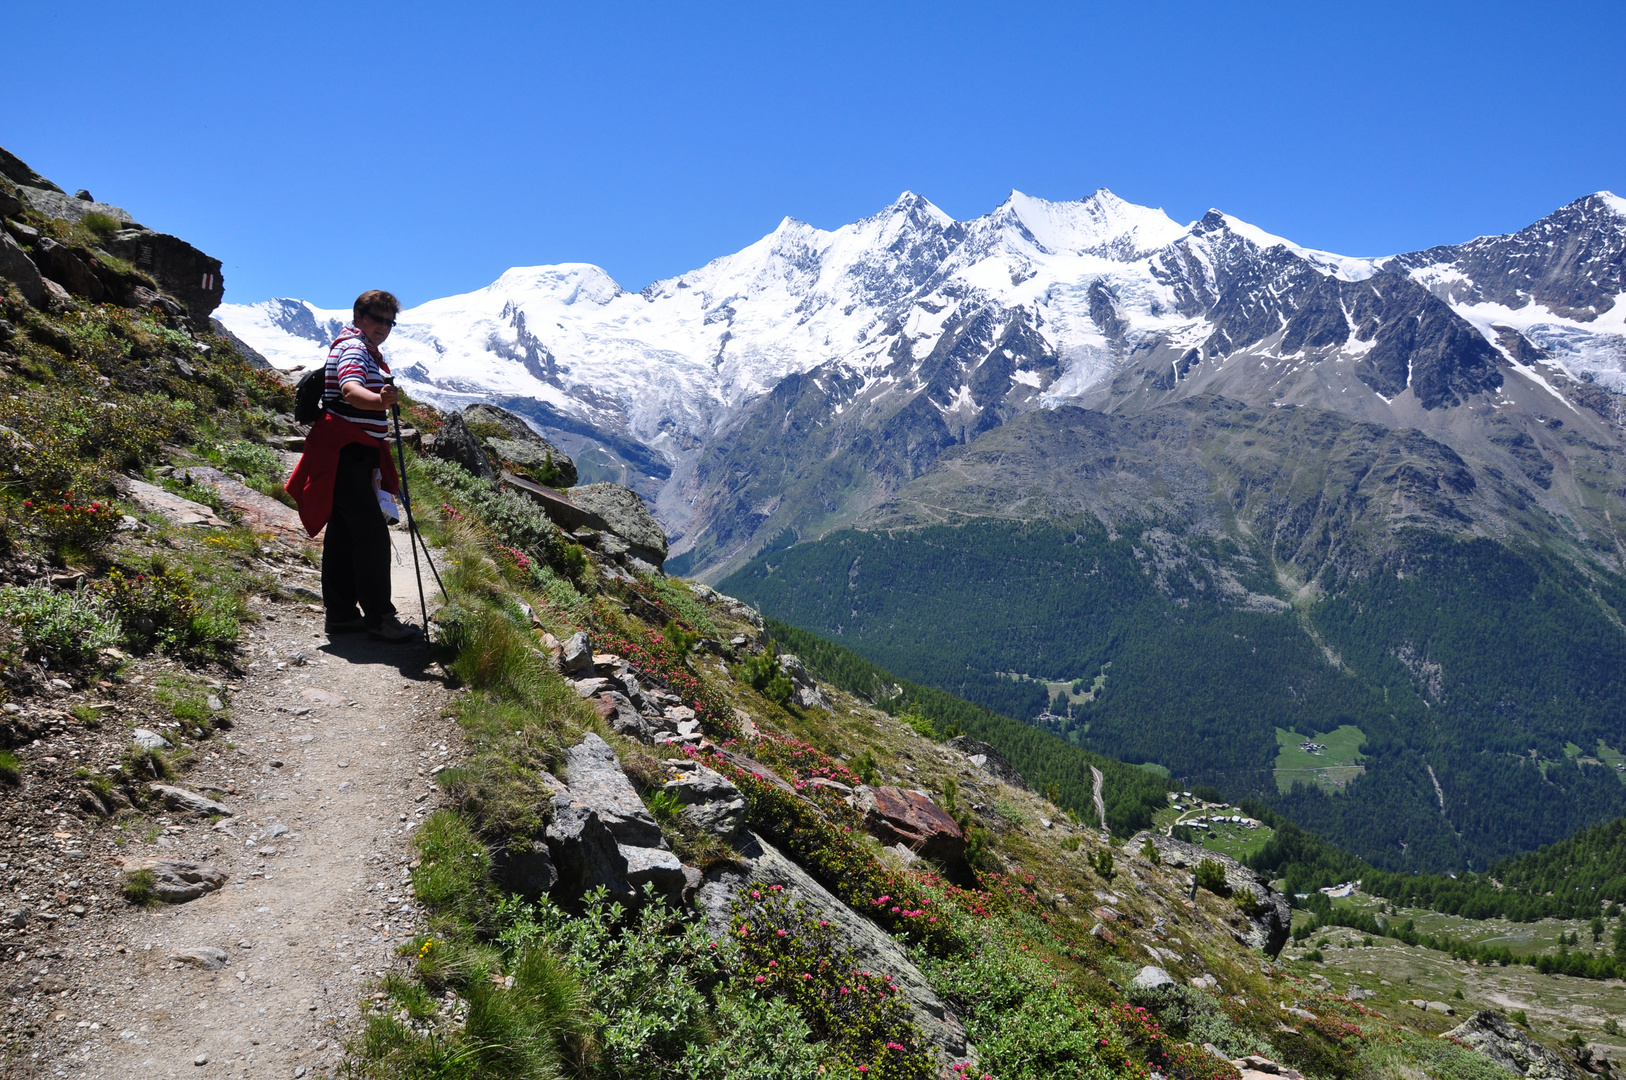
[[0, 0, 1626, 307]]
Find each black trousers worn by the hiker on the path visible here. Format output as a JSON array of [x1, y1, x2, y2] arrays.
[[322, 442, 395, 626]]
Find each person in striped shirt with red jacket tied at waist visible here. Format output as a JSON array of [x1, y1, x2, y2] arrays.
[[286, 290, 420, 641]]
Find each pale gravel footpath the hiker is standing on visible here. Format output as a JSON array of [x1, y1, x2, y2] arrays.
[[15, 530, 462, 1080]]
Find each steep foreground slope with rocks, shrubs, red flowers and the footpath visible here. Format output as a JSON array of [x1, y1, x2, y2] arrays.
[[0, 145, 1606, 1080]]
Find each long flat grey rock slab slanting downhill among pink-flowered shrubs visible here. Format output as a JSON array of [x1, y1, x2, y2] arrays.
[[696, 833, 966, 1060]]
